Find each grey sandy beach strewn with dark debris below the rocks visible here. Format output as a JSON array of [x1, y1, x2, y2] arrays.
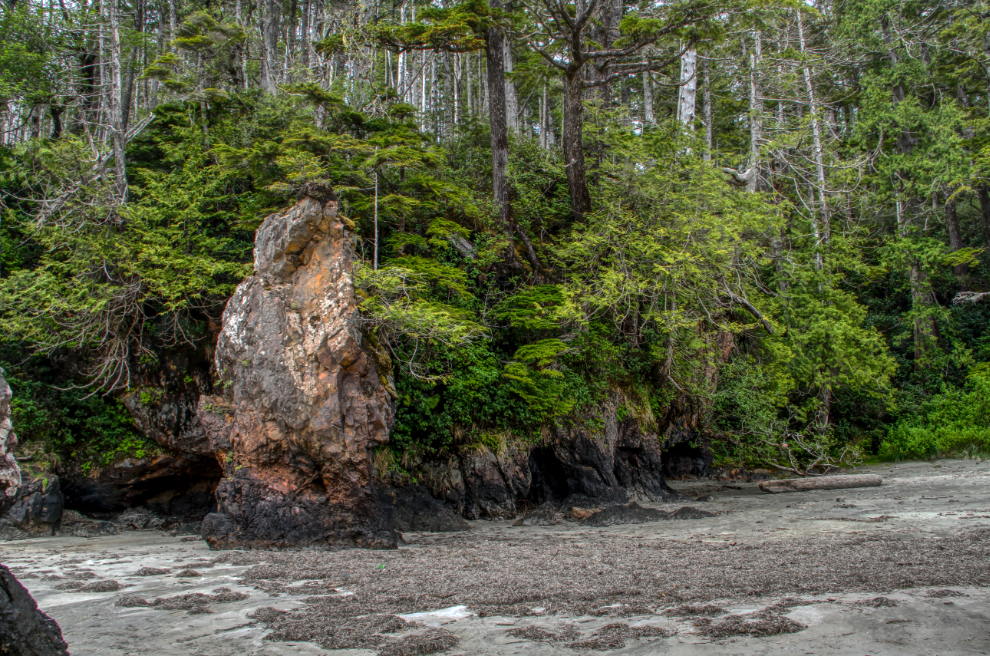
[[0, 460, 990, 656]]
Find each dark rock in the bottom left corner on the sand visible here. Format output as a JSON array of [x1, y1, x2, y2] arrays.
[[0, 565, 69, 656]]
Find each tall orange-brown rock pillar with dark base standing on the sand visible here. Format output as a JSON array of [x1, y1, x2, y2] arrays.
[[199, 186, 398, 549]]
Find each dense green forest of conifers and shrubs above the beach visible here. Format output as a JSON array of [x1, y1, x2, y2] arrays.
[[0, 0, 990, 474]]
